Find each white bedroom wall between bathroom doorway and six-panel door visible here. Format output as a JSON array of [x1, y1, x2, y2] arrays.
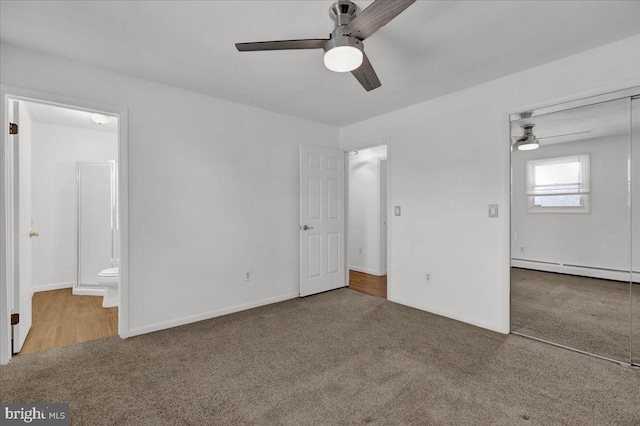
[[0, 45, 338, 334]]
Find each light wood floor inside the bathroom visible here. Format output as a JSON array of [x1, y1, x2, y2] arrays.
[[19, 288, 118, 355]]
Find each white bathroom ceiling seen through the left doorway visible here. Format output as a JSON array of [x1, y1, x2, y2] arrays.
[[24, 102, 118, 133]]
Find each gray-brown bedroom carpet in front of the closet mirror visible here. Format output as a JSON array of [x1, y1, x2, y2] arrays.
[[0, 289, 640, 425]]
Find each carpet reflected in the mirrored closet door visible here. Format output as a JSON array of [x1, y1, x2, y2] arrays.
[[511, 268, 640, 362]]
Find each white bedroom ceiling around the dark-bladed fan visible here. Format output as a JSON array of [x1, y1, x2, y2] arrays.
[[0, 0, 640, 126]]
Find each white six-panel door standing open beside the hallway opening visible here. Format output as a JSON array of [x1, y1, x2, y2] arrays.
[[300, 145, 346, 296]]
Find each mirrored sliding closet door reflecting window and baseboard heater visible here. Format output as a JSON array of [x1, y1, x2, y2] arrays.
[[510, 91, 640, 364]]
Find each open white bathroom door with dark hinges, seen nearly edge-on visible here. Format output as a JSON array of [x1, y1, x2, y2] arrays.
[[12, 101, 33, 353]]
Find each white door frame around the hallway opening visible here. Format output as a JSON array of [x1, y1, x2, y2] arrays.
[[342, 136, 393, 300]]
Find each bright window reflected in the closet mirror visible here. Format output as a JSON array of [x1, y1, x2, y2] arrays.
[[527, 154, 590, 213]]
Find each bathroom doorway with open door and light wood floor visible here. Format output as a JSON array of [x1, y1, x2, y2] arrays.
[[0, 88, 128, 364]]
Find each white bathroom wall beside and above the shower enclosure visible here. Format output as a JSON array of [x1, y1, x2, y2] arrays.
[[32, 122, 118, 291]]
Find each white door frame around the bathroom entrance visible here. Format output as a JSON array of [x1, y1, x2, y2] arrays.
[[0, 84, 129, 365]]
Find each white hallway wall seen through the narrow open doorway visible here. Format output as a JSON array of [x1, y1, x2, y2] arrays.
[[347, 153, 385, 276]]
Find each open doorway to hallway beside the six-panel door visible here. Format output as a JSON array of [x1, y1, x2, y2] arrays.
[[347, 145, 388, 299]]
